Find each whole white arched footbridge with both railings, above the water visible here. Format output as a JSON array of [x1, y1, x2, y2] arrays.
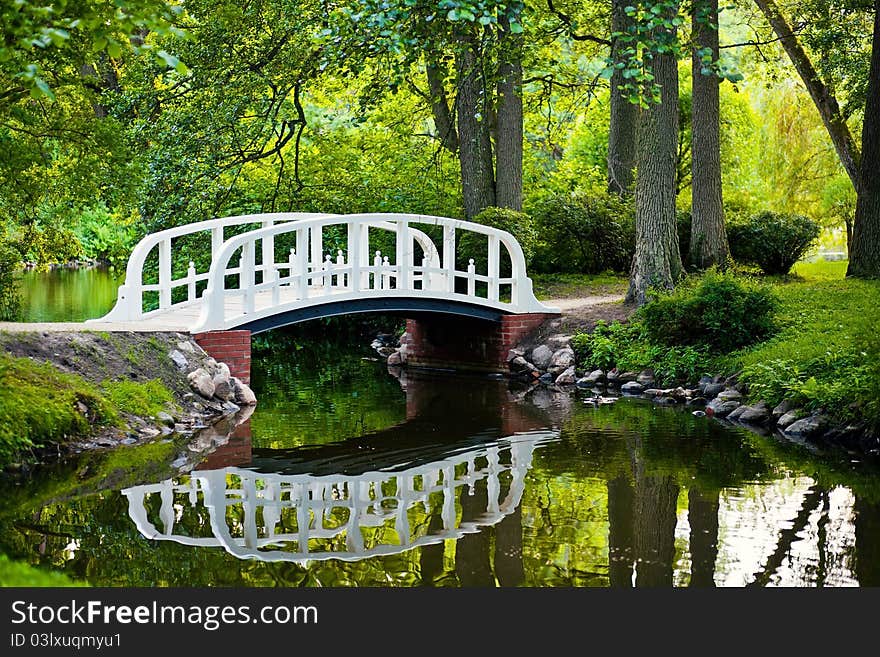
[[88, 213, 558, 333]]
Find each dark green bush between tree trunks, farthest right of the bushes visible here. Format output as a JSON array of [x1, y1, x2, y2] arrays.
[[727, 212, 820, 274]]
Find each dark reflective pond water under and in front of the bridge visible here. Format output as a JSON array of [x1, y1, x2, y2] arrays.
[[6, 270, 880, 587]]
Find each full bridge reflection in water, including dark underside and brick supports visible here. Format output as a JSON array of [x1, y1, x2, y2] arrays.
[[122, 379, 558, 564]]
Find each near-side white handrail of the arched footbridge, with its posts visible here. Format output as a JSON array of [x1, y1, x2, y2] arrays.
[[193, 213, 553, 331]]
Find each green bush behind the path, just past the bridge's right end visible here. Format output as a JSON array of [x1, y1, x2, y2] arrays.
[[533, 192, 635, 274]]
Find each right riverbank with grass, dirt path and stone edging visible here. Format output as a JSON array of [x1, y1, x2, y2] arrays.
[[392, 261, 880, 454]]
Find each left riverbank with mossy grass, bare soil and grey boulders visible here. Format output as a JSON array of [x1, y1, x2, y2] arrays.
[[0, 331, 255, 471]]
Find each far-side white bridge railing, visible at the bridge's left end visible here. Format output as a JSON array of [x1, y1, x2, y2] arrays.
[[90, 212, 329, 322]]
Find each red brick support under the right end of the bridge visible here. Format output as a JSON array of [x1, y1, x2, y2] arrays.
[[406, 313, 558, 373]]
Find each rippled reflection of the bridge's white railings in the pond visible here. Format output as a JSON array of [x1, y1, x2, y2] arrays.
[[122, 431, 556, 563]]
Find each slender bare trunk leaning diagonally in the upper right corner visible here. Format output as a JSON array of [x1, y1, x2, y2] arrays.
[[755, 0, 864, 191]]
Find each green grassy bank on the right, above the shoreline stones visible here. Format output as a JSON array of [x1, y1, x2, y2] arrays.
[[573, 261, 880, 427]]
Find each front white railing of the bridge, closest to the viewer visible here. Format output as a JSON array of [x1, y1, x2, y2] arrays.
[[192, 214, 550, 331]]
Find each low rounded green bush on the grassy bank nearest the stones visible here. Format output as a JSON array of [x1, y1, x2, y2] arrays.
[[639, 271, 777, 353]]
